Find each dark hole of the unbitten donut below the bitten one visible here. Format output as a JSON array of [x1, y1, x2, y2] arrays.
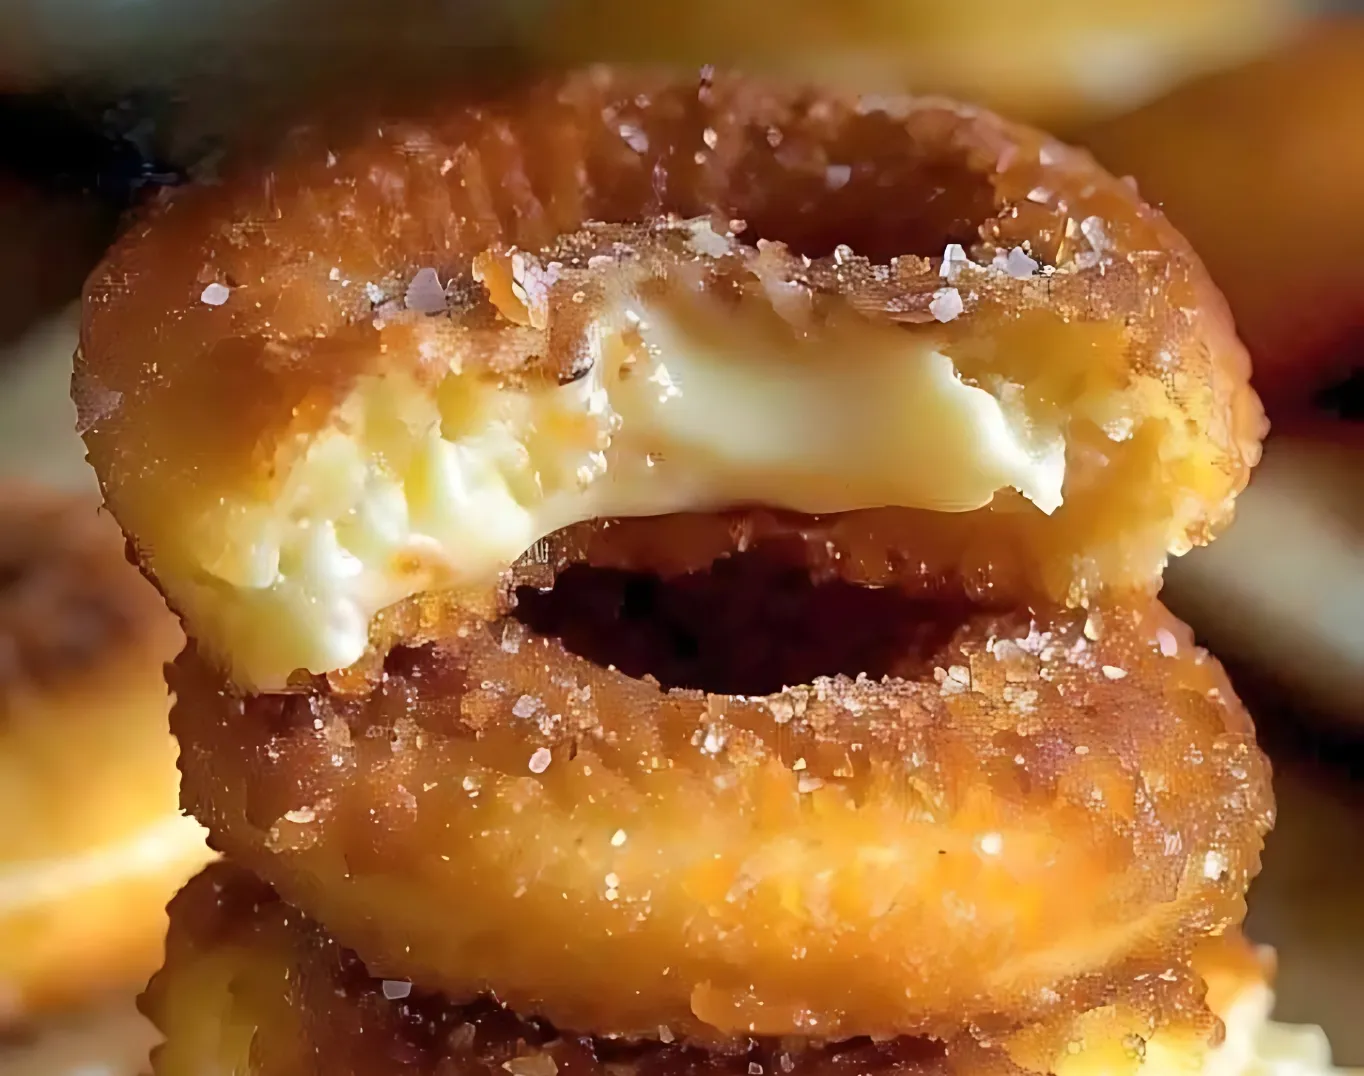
[[514, 550, 971, 696]]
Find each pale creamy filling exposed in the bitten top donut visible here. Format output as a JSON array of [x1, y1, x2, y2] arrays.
[[181, 303, 1065, 689]]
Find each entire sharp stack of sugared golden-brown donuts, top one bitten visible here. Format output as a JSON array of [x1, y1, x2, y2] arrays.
[[74, 70, 1273, 1076]]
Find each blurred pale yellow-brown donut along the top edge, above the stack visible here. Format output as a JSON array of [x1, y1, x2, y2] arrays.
[[532, 0, 1300, 128]]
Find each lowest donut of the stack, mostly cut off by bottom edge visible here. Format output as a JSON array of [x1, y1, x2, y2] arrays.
[[140, 863, 1333, 1076]]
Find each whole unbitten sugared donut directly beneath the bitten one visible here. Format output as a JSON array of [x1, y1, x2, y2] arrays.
[[169, 546, 1273, 1038]]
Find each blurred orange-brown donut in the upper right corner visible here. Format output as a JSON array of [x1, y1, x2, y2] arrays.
[[1084, 18, 1364, 419]]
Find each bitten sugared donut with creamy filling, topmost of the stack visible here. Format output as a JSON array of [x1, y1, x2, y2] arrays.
[[74, 70, 1263, 690]]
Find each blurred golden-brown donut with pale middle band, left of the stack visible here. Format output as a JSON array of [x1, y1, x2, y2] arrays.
[[0, 483, 209, 1027]]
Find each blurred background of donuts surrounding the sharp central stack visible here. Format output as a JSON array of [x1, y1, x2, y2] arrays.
[[0, 0, 1364, 1076]]
